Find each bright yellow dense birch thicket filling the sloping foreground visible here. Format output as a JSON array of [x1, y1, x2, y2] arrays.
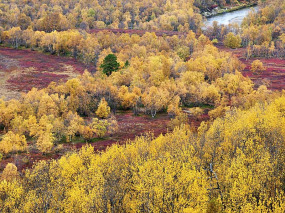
[[0, 97, 285, 213]]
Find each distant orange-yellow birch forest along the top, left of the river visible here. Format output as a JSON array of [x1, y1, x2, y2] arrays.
[[0, 0, 258, 32]]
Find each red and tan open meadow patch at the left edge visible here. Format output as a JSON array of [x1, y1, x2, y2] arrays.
[[0, 47, 95, 99]]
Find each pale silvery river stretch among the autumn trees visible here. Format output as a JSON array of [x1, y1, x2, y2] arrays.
[[204, 6, 258, 28]]
